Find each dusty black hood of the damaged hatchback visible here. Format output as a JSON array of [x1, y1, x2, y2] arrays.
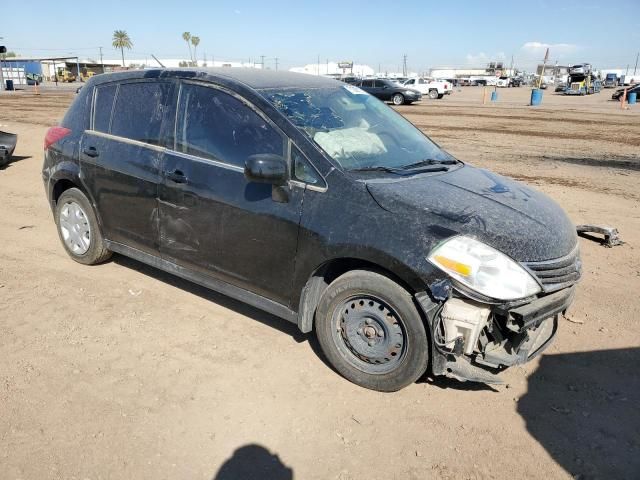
[[367, 165, 577, 262]]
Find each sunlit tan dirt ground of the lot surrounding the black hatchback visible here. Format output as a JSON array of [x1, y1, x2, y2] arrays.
[[0, 87, 640, 480]]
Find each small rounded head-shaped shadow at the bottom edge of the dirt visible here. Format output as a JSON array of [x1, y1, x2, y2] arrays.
[[212, 444, 293, 480]]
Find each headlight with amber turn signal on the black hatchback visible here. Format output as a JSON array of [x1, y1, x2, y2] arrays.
[[427, 236, 540, 300]]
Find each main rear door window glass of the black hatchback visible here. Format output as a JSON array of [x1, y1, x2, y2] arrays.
[[111, 82, 172, 145]]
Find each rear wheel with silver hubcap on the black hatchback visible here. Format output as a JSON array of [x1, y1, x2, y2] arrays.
[[55, 188, 111, 265]]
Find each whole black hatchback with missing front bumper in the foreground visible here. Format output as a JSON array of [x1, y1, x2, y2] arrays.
[[43, 69, 580, 391]]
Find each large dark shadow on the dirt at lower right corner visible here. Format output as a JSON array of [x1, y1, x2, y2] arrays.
[[518, 348, 640, 479]]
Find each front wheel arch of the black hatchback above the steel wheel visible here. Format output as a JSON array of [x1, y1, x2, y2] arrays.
[[298, 257, 418, 333]]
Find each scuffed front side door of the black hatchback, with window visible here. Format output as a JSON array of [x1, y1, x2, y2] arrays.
[[159, 82, 305, 305]]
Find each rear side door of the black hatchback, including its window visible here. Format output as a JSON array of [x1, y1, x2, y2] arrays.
[[80, 80, 173, 254]]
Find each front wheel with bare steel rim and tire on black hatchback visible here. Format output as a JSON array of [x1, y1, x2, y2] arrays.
[[315, 270, 429, 392]]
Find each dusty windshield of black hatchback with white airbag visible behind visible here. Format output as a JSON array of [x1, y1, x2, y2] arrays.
[[263, 85, 455, 170]]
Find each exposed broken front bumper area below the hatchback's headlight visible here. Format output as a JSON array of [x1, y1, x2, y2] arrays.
[[416, 286, 575, 383]]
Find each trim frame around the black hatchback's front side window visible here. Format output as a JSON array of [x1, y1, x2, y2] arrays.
[[168, 80, 291, 172]]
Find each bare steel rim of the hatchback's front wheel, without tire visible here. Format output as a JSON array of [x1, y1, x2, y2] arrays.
[[333, 295, 407, 374]]
